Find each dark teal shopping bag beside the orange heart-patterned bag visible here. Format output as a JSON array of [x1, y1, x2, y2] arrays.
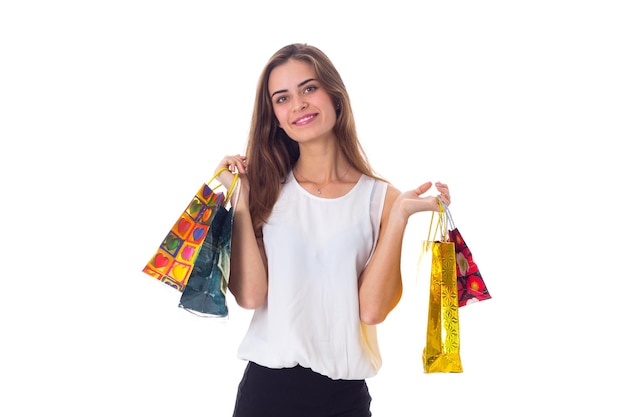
[[178, 205, 234, 318]]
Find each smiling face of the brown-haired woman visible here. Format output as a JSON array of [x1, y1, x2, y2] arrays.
[[268, 59, 337, 143]]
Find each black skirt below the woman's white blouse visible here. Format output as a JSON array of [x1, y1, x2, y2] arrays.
[[233, 362, 372, 417]]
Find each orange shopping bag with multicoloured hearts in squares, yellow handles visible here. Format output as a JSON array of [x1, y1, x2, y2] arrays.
[[143, 168, 238, 291]]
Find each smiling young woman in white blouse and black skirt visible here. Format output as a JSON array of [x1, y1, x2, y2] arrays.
[[217, 44, 450, 417]]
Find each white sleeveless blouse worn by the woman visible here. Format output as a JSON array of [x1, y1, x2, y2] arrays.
[[238, 173, 387, 379]]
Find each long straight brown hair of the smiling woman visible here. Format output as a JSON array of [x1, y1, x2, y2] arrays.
[[246, 43, 375, 235]]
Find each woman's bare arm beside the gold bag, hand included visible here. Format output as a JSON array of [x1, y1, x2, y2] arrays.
[[359, 182, 450, 324]]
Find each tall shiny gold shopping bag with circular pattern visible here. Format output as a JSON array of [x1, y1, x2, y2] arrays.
[[422, 201, 463, 373]]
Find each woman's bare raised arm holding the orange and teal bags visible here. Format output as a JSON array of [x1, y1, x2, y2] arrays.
[[217, 155, 267, 309]]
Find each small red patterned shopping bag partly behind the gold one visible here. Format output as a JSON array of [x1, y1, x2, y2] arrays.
[[442, 203, 491, 307]]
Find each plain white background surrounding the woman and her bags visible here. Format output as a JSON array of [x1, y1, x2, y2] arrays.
[[0, 0, 626, 417]]
